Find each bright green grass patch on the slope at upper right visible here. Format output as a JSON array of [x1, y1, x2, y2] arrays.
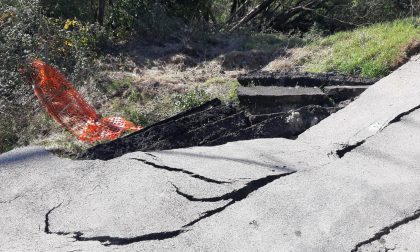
[[304, 19, 420, 77]]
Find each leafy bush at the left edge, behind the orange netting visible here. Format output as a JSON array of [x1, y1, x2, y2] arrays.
[[0, 0, 101, 151]]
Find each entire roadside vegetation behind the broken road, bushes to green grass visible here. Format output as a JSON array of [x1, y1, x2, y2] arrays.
[[0, 0, 420, 153]]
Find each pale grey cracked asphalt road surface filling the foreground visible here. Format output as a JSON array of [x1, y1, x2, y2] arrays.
[[0, 57, 420, 251]]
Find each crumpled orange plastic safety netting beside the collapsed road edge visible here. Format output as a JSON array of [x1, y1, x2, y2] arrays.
[[32, 60, 143, 143]]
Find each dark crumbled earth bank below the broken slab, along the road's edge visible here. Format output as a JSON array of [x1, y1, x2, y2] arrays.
[[79, 99, 330, 160]]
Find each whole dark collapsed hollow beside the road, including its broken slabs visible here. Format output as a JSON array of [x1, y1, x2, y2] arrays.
[[78, 72, 376, 160]]
